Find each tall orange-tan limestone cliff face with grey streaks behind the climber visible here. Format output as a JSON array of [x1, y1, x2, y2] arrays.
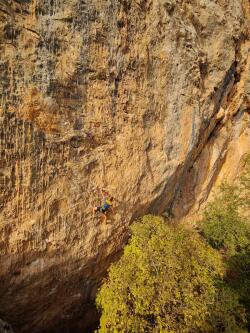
[[0, 0, 250, 333]]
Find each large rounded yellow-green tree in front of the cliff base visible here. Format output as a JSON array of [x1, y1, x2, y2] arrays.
[[96, 216, 225, 333]]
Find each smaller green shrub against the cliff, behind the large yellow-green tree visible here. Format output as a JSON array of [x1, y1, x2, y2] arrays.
[[201, 154, 250, 257]]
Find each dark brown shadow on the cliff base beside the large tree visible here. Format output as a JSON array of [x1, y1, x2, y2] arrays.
[[0, 241, 125, 333]]
